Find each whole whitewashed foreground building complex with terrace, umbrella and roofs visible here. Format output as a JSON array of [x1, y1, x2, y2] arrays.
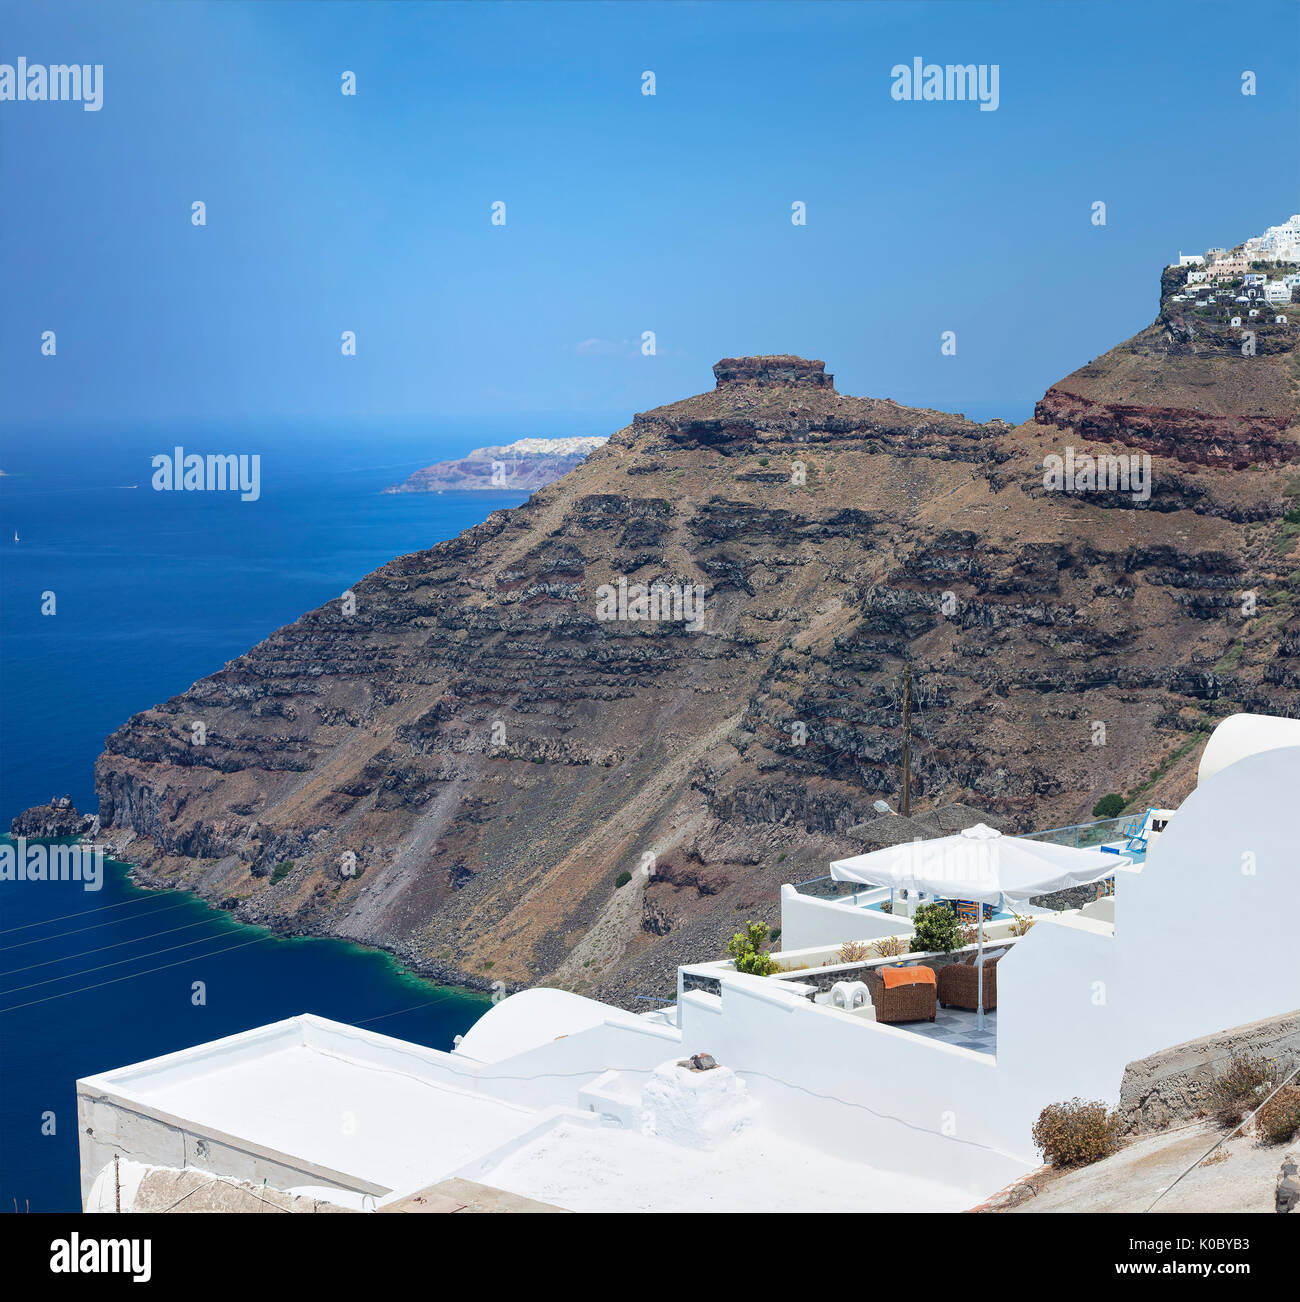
[[77, 713, 1300, 1212]]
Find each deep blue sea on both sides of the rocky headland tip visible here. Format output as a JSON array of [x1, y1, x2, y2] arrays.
[[0, 414, 614, 1211]]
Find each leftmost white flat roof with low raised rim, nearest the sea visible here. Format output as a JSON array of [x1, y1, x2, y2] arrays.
[[77, 1016, 544, 1191]]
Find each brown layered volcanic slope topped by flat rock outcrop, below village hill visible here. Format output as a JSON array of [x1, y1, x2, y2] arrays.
[[96, 312, 1300, 1000]]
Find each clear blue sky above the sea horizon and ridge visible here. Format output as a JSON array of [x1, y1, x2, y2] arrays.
[[0, 0, 1300, 432]]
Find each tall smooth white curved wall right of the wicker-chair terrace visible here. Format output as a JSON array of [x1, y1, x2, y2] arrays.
[[998, 747, 1300, 1109]]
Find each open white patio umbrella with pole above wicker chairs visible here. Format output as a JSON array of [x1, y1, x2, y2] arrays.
[[831, 823, 1129, 1026]]
